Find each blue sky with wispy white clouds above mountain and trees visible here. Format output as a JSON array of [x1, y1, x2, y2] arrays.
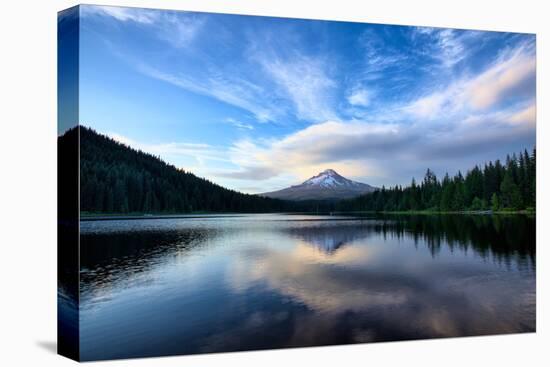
[[70, 5, 536, 193]]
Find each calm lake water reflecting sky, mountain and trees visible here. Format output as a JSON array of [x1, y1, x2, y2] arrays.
[[80, 215, 536, 360]]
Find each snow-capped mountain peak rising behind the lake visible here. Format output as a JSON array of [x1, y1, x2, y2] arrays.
[[259, 169, 377, 200]]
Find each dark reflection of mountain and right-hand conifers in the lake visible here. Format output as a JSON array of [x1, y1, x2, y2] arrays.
[[283, 215, 536, 266]]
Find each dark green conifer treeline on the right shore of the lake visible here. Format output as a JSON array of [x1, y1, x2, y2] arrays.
[[337, 149, 536, 211]]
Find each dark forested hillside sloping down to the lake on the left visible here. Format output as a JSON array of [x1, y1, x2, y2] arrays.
[[76, 126, 295, 213]]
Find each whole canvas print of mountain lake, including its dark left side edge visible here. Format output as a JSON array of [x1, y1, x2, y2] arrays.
[[58, 5, 536, 361]]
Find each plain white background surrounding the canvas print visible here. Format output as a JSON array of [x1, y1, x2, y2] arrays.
[[0, 0, 550, 367]]
